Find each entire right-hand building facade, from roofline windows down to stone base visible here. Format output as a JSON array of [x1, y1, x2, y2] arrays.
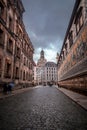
[[57, 0, 87, 91]]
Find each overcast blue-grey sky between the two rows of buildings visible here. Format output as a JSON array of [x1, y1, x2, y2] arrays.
[[22, 0, 75, 63]]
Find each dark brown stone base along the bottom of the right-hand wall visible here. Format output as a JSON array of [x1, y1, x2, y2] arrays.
[[59, 74, 87, 95]]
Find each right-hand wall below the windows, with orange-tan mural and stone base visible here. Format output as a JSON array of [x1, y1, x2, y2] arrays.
[[58, 20, 87, 93]]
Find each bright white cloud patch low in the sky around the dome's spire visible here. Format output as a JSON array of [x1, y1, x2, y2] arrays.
[[34, 39, 62, 62]]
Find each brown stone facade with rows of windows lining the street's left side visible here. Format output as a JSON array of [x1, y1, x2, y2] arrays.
[[0, 0, 34, 89]]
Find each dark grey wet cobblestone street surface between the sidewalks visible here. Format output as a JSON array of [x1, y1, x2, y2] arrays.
[[0, 86, 87, 130]]
